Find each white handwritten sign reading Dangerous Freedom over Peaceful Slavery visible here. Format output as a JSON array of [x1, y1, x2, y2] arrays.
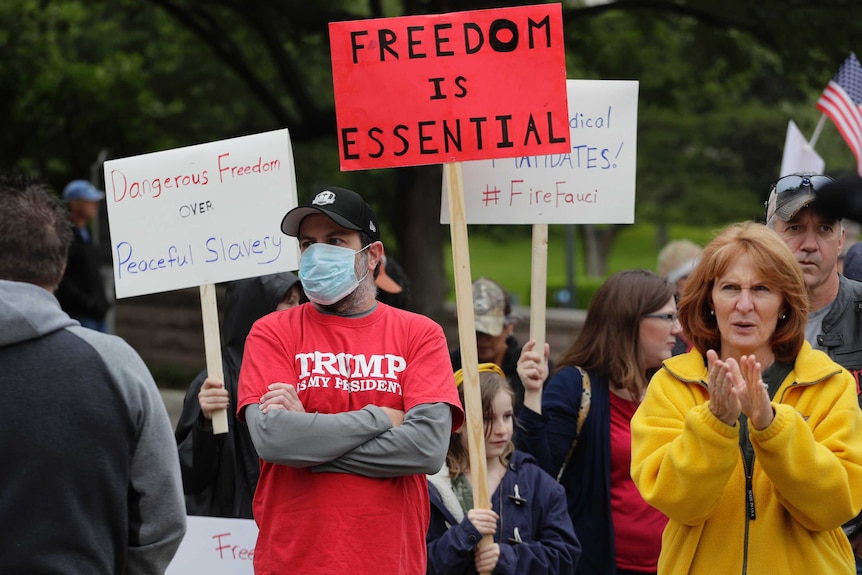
[[105, 130, 299, 298]]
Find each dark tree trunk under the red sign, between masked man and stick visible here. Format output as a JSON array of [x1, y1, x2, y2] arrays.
[[398, 165, 446, 320]]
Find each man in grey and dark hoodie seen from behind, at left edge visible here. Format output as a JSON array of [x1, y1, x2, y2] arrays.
[[0, 177, 186, 575]]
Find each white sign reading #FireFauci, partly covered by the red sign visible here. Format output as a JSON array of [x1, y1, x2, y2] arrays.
[[440, 80, 638, 224]]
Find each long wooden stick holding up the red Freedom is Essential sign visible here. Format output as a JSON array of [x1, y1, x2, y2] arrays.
[[443, 162, 493, 572]]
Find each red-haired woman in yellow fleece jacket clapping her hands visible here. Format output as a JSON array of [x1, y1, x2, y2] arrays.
[[631, 222, 862, 575]]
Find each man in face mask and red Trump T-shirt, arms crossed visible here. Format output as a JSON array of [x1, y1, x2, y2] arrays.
[[238, 186, 464, 575]]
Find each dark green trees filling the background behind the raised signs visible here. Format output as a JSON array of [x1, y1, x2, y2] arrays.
[[0, 0, 862, 315]]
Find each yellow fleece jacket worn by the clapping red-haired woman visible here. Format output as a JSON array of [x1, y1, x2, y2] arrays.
[[631, 343, 862, 575]]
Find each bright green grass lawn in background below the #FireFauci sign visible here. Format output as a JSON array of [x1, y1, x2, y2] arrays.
[[445, 223, 722, 308]]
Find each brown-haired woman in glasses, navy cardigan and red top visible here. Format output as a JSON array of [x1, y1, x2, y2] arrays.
[[516, 270, 681, 575]]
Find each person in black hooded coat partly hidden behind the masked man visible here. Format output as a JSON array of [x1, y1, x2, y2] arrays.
[[175, 272, 304, 519]]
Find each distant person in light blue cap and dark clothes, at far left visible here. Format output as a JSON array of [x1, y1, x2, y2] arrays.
[[57, 180, 111, 332]]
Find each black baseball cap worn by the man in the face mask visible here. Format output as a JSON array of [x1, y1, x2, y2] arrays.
[[281, 186, 380, 241]]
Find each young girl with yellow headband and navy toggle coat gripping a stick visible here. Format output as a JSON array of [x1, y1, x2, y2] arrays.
[[428, 363, 581, 575]]
